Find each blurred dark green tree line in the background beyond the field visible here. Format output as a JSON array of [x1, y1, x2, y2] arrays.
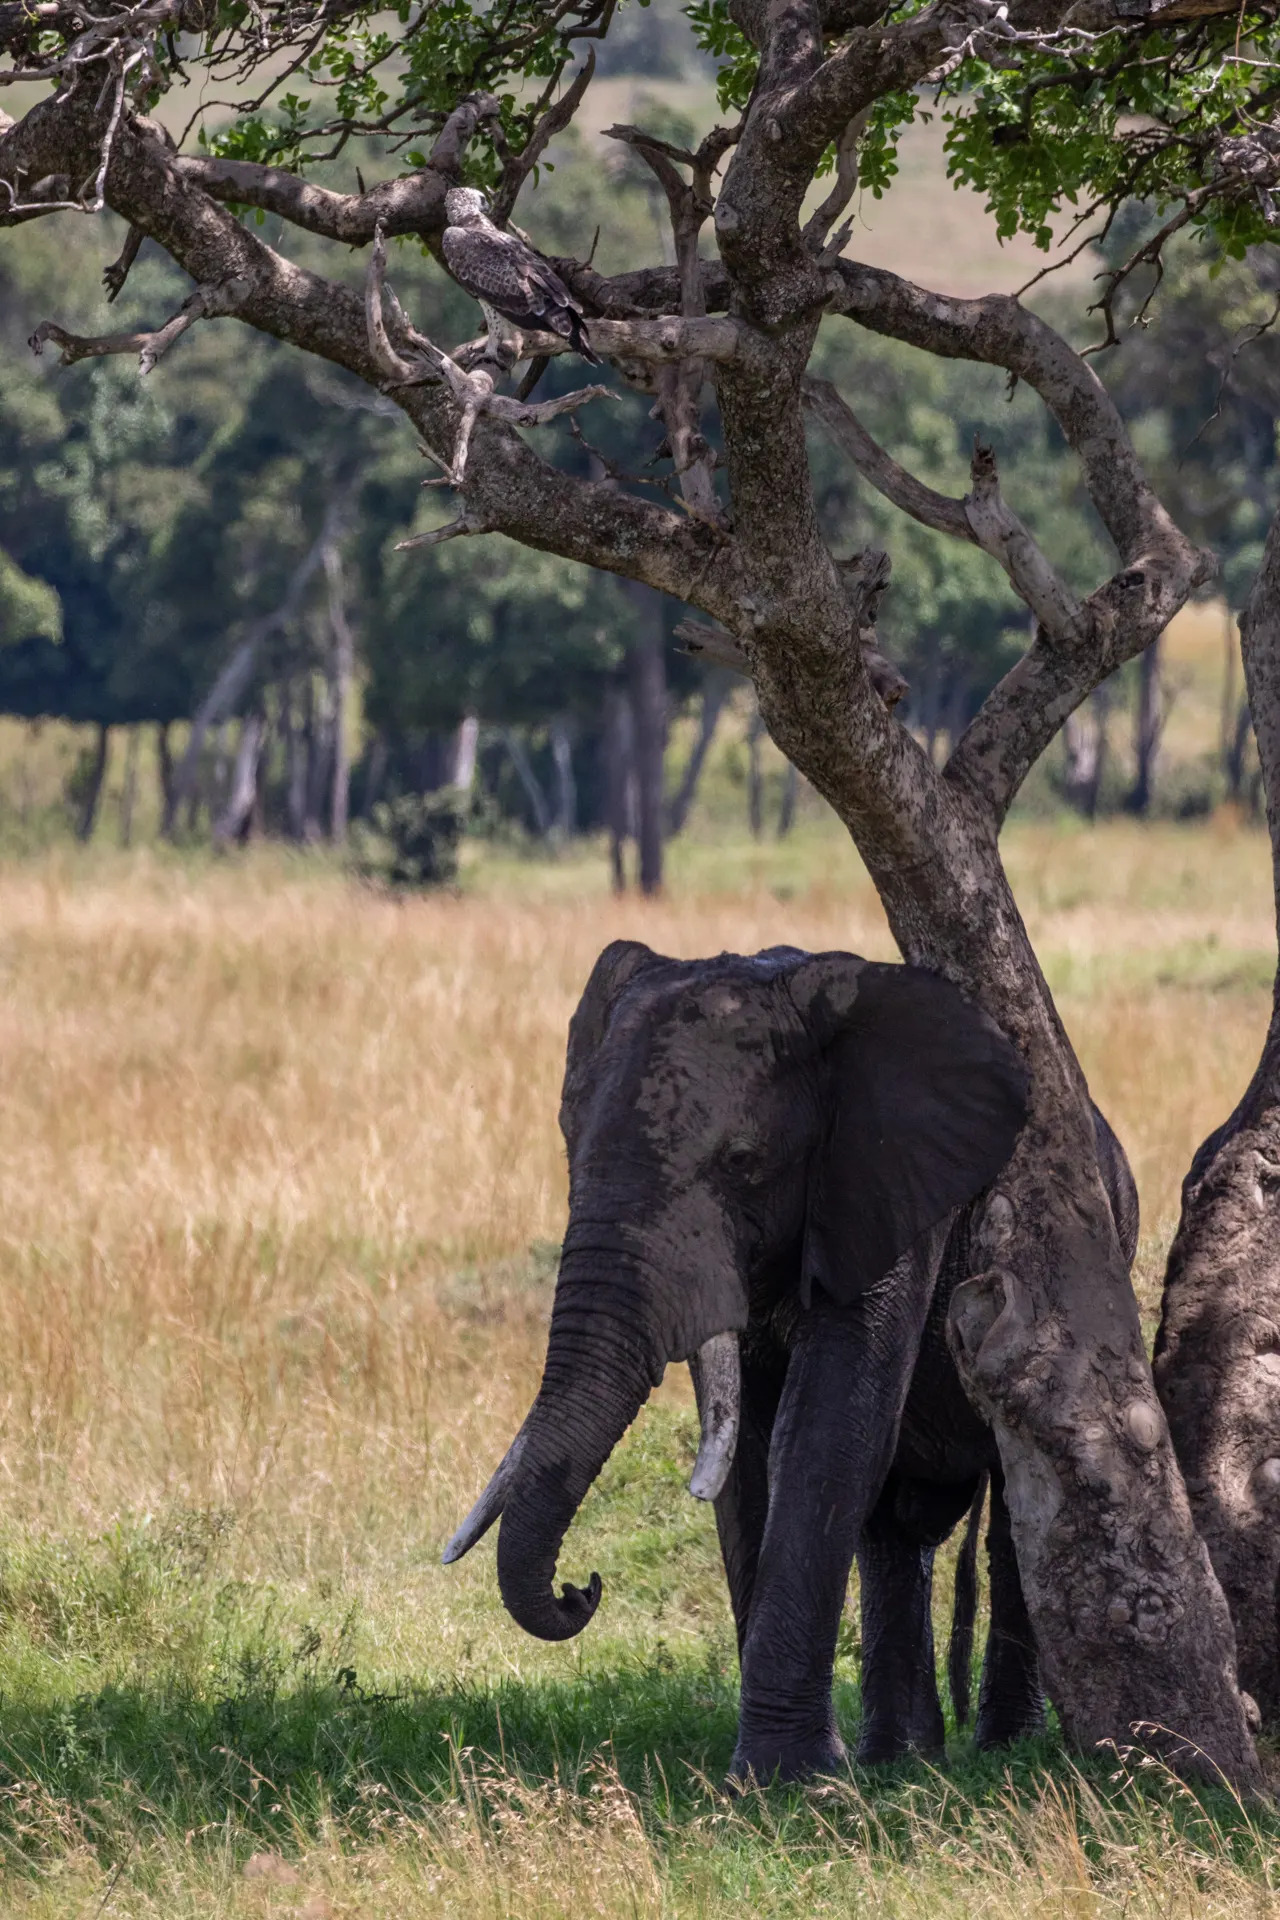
[[0, 24, 1280, 887]]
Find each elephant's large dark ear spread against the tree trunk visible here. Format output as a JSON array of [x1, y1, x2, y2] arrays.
[[804, 964, 1027, 1302]]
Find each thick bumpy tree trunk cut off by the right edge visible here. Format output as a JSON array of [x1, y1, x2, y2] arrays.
[[1155, 515, 1280, 1722]]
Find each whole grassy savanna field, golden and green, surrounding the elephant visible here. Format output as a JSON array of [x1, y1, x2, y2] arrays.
[[0, 816, 1280, 1920]]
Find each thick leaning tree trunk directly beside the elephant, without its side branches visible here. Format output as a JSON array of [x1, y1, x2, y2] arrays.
[[718, 318, 1259, 1784]]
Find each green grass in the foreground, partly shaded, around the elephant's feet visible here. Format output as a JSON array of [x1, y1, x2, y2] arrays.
[[0, 1405, 1280, 1914]]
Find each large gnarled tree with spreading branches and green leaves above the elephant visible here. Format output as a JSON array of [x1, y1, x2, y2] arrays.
[[0, 0, 1280, 1784]]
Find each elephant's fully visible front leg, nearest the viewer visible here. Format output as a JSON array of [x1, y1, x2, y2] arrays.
[[731, 1267, 929, 1780]]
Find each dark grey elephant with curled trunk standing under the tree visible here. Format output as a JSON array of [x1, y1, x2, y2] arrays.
[[445, 941, 1136, 1782]]
